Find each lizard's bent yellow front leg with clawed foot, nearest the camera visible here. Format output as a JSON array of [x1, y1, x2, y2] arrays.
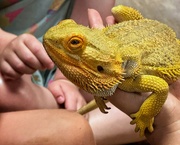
[[119, 75, 168, 136]]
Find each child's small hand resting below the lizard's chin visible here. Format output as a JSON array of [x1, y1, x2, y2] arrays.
[[48, 70, 86, 110]]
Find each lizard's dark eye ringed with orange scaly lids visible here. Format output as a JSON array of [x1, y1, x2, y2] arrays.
[[68, 36, 84, 52]]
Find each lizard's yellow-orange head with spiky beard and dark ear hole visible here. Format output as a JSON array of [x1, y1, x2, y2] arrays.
[[43, 20, 123, 96]]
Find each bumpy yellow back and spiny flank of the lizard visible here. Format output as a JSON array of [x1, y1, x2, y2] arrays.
[[105, 19, 180, 82]]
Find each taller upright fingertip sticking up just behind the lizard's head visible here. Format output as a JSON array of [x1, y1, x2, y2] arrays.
[[88, 9, 104, 28]]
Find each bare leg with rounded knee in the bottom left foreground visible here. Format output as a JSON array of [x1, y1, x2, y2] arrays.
[[0, 109, 95, 145]]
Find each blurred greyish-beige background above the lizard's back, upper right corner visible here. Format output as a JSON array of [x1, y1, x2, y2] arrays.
[[116, 0, 180, 39]]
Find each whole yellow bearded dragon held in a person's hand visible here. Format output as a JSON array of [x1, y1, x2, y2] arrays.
[[43, 5, 180, 136]]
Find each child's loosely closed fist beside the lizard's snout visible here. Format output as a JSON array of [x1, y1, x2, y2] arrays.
[[0, 34, 54, 80]]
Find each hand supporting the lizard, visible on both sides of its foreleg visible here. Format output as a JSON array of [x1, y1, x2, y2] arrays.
[[108, 80, 180, 145]]
